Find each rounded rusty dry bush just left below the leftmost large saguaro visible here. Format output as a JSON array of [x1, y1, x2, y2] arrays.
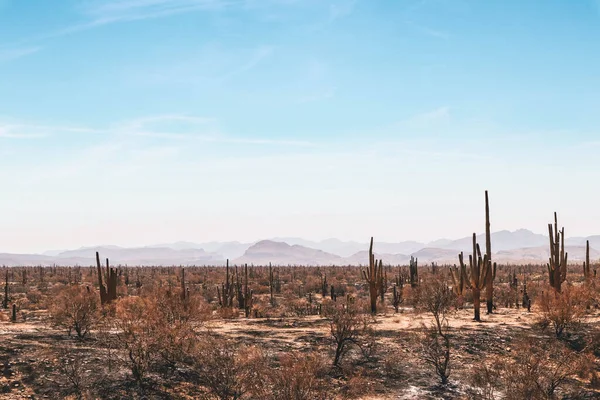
[[50, 286, 100, 339]]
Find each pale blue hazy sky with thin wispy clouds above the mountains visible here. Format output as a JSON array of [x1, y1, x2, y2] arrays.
[[0, 0, 600, 252]]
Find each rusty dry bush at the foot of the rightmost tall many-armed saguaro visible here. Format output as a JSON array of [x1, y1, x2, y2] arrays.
[[539, 285, 585, 338]]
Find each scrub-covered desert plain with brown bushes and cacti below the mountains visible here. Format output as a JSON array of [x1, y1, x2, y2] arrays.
[[0, 193, 600, 400]]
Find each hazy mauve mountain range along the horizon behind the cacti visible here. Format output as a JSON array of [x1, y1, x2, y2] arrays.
[[0, 229, 600, 266]]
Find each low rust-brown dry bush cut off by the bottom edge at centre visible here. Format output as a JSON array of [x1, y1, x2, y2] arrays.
[[268, 352, 329, 400]]
